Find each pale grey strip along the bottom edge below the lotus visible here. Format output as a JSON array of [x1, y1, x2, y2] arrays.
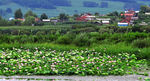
[[0, 75, 150, 81]]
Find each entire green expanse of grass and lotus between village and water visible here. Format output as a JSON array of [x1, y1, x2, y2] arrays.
[[0, 23, 150, 76]]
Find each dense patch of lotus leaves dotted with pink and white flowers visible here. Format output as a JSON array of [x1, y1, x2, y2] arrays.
[[0, 48, 146, 76]]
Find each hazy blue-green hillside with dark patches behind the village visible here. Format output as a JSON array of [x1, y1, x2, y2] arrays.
[[0, 0, 150, 18]]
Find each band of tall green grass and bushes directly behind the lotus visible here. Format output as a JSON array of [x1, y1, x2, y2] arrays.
[[0, 32, 150, 59]]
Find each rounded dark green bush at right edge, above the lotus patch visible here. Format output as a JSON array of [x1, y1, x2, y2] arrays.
[[133, 38, 150, 48]]
